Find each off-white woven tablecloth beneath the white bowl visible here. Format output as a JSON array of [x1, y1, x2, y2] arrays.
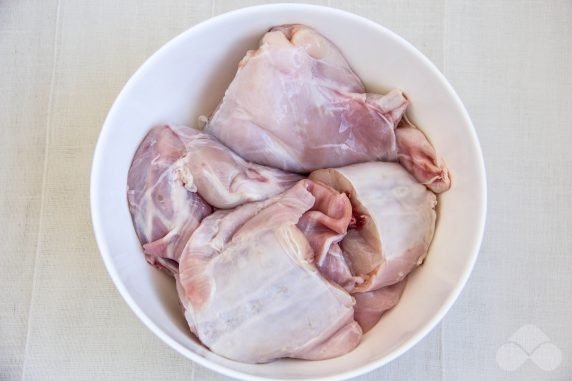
[[0, 0, 572, 381]]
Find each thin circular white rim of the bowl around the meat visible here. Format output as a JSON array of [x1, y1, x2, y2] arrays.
[[90, 3, 487, 381]]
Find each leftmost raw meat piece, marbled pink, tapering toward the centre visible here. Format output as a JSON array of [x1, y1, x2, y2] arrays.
[[127, 125, 301, 273]]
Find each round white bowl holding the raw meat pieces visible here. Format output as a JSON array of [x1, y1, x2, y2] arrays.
[[91, 4, 486, 380]]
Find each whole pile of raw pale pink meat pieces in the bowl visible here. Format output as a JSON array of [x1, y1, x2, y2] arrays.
[[128, 25, 451, 362]]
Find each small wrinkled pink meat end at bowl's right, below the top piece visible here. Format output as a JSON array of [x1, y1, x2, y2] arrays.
[[395, 117, 451, 193]]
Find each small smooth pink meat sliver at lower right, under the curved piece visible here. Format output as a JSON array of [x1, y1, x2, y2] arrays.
[[353, 279, 407, 333]]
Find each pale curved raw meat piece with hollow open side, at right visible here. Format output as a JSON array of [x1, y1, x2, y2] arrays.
[[310, 162, 437, 292]]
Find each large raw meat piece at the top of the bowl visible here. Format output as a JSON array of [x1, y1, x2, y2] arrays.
[[206, 25, 407, 173]]
